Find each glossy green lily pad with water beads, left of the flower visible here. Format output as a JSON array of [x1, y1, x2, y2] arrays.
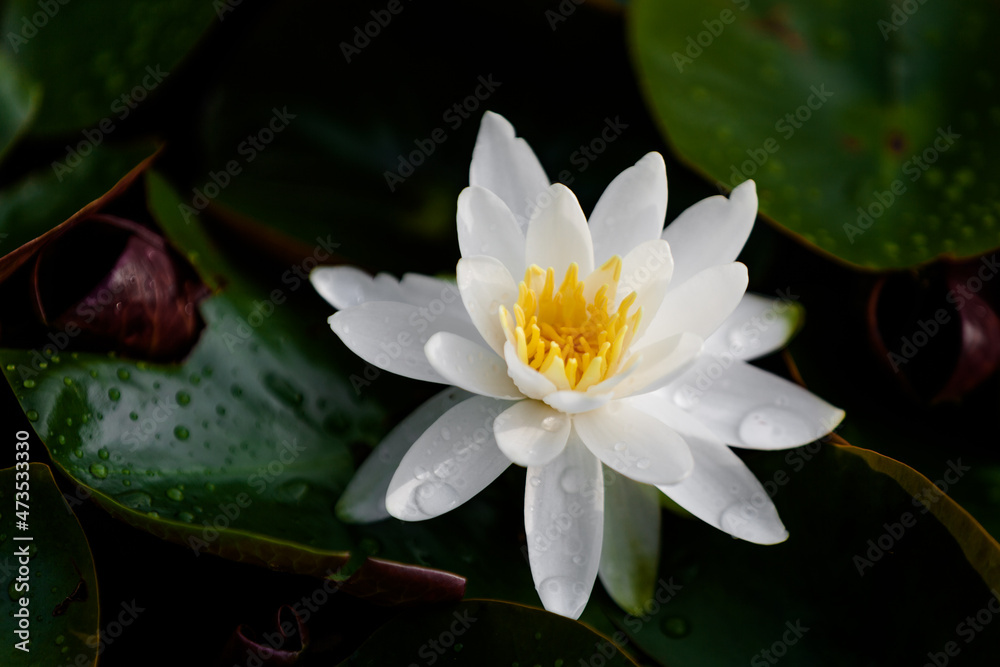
[[0, 171, 379, 575]]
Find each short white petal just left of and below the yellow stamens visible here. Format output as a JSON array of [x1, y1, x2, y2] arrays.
[[424, 331, 524, 401]]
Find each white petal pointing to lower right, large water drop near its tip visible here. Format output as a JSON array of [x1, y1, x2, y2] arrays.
[[629, 395, 788, 544]]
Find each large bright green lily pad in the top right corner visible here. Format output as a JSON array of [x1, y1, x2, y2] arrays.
[[630, 0, 1000, 269]]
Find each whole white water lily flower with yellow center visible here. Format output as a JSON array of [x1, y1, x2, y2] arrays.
[[312, 113, 843, 618]]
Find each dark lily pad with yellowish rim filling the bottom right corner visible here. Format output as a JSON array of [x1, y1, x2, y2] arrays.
[[607, 443, 1000, 667]]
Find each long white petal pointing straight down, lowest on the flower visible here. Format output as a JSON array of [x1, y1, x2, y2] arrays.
[[524, 433, 604, 618]]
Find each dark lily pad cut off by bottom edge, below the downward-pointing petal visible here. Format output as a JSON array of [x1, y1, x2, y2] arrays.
[[341, 600, 636, 667]]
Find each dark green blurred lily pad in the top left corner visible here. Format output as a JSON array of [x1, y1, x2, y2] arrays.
[[0, 0, 217, 136]]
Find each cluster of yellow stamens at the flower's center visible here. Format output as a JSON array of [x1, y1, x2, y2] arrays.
[[500, 256, 642, 391]]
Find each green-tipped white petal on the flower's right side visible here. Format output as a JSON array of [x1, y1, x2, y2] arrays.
[[705, 292, 805, 361]]
